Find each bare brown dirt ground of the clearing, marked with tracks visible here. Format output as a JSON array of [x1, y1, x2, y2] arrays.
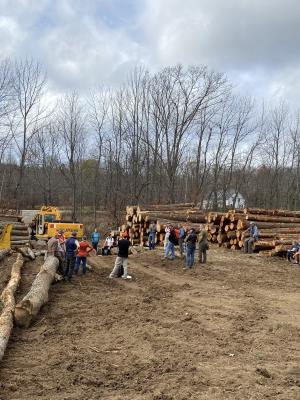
[[0, 247, 300, 400]]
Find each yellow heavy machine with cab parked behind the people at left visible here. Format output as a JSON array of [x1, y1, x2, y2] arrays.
[[32, 206, 83, 240]]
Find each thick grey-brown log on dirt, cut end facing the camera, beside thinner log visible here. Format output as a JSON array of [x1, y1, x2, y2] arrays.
[[15, 256, 59, 327]]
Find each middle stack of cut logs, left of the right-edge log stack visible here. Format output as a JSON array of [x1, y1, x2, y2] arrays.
[[120, 203, 206, 246]]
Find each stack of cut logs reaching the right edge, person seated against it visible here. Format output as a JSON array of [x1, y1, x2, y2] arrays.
[[206, 208, 300, 255]]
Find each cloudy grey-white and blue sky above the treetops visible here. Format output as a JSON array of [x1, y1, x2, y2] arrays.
[[0, 0, 300, 106]]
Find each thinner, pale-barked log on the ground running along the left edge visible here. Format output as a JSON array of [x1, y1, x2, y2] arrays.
[[0, 254, 24, 361]]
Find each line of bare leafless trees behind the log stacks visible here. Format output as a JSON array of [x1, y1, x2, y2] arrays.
[[0, 59, 300, 220]]
